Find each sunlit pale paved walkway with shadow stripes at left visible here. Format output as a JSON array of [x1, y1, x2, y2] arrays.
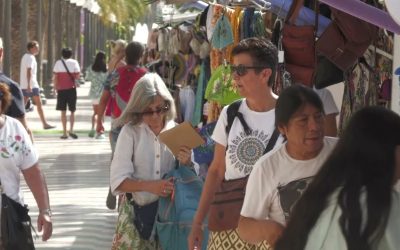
[[22, 83, 117, 250]]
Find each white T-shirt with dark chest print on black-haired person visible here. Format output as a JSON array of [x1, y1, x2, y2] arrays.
[[240, 137, 337, 225]]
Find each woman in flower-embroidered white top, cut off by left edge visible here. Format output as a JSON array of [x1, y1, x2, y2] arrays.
[[0, 83, 53, 250]]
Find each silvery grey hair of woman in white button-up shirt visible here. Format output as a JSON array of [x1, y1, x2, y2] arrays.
[[113, 73, 176, 127]]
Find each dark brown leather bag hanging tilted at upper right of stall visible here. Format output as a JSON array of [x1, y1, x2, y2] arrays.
[[316, 8, 378, 71]]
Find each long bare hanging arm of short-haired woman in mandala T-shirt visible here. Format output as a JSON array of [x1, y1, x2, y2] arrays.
[[188, 143, 226, 250]]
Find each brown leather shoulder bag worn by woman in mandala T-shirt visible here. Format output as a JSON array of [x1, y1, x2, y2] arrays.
[[208, 129, 279, 232]]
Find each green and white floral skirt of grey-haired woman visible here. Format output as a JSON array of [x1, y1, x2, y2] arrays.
[[111, 196, 161, 250]]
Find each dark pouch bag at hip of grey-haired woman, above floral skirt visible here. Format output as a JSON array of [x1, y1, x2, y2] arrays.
[[131, 199, 158, 240]]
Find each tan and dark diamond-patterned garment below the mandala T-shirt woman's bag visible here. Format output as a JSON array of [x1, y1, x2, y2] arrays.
[[207, 229, 272, 250]]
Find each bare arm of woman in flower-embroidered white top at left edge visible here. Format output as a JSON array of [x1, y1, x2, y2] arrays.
[[22, 163, 53, 241]]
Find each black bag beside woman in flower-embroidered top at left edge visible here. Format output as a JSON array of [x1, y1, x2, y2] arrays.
[[0, 182, 35, 250]]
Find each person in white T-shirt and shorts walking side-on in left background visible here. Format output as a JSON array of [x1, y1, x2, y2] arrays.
[[19, 41, 55, 129]]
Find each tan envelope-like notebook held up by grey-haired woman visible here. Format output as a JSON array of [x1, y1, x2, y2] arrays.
[[160, 122, 204, 156]]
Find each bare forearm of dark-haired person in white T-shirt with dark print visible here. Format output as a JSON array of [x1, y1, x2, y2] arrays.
[[238, 216, 284, 246]]
